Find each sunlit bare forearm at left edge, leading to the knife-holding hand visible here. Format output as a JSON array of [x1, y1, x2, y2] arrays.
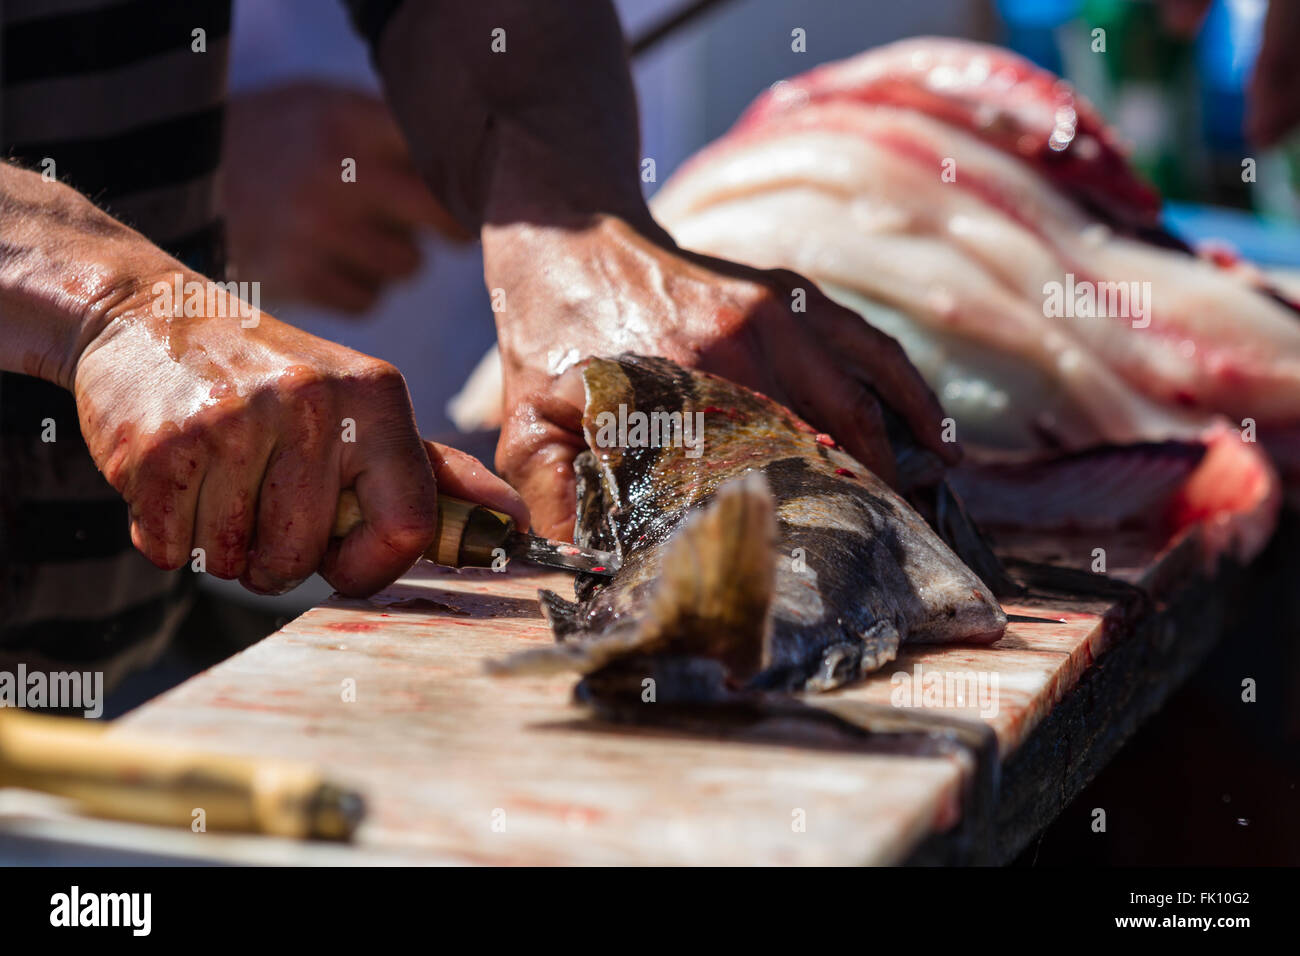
[[0, 163, 178, 389]]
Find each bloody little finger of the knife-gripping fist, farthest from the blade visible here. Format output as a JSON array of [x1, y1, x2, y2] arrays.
[[126, 437, 205, 571]]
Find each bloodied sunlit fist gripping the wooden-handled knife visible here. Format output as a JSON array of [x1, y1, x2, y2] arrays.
[[75, 273, 528, 596]]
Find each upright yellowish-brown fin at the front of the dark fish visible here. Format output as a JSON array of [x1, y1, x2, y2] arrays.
[[642, 472, 776, 679]]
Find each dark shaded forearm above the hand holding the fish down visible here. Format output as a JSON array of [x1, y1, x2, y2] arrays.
[[377, 0, 649, 232]]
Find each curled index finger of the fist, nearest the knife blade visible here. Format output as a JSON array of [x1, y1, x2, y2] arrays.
[[321, 369, 438, 597]]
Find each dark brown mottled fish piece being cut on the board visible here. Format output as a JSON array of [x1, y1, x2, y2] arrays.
[[491, 354, 1006, 704]]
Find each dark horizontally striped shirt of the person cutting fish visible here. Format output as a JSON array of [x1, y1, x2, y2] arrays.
[[0, 0, 397, 683]]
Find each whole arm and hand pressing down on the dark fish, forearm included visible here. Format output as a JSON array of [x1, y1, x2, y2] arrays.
[[377, 0, 957, 536]]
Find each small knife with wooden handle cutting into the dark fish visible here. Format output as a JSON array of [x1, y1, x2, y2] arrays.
[[334, 490, 619, 578]]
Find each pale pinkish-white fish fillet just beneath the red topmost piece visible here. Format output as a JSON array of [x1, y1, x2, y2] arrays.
[[651, 94, 1300, 442]]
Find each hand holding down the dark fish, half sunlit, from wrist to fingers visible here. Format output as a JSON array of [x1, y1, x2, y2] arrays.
[[484, 217, 959, 537]]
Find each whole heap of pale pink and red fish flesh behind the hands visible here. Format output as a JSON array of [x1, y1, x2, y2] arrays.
[[651, 38, 1279, 563]]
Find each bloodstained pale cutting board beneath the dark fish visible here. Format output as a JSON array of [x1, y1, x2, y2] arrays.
[[30, 522, 1206, 864]]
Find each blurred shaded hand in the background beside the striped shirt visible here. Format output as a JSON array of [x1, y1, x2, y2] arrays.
[[220, 82, 468, 313]]
